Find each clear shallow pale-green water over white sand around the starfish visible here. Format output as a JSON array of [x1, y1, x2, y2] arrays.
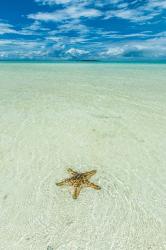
[[0, 63, 166, 250]]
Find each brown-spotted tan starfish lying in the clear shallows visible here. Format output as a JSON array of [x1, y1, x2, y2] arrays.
[[56, 168, 101, 199]]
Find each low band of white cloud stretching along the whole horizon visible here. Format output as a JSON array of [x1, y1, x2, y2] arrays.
[[0, 32, 166, 59]]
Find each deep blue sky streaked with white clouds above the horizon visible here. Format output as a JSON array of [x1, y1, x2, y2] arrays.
[[0, 0, 166, 60]]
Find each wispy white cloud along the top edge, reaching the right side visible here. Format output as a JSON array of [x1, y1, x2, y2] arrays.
[[32, 0, 166, 23]]
